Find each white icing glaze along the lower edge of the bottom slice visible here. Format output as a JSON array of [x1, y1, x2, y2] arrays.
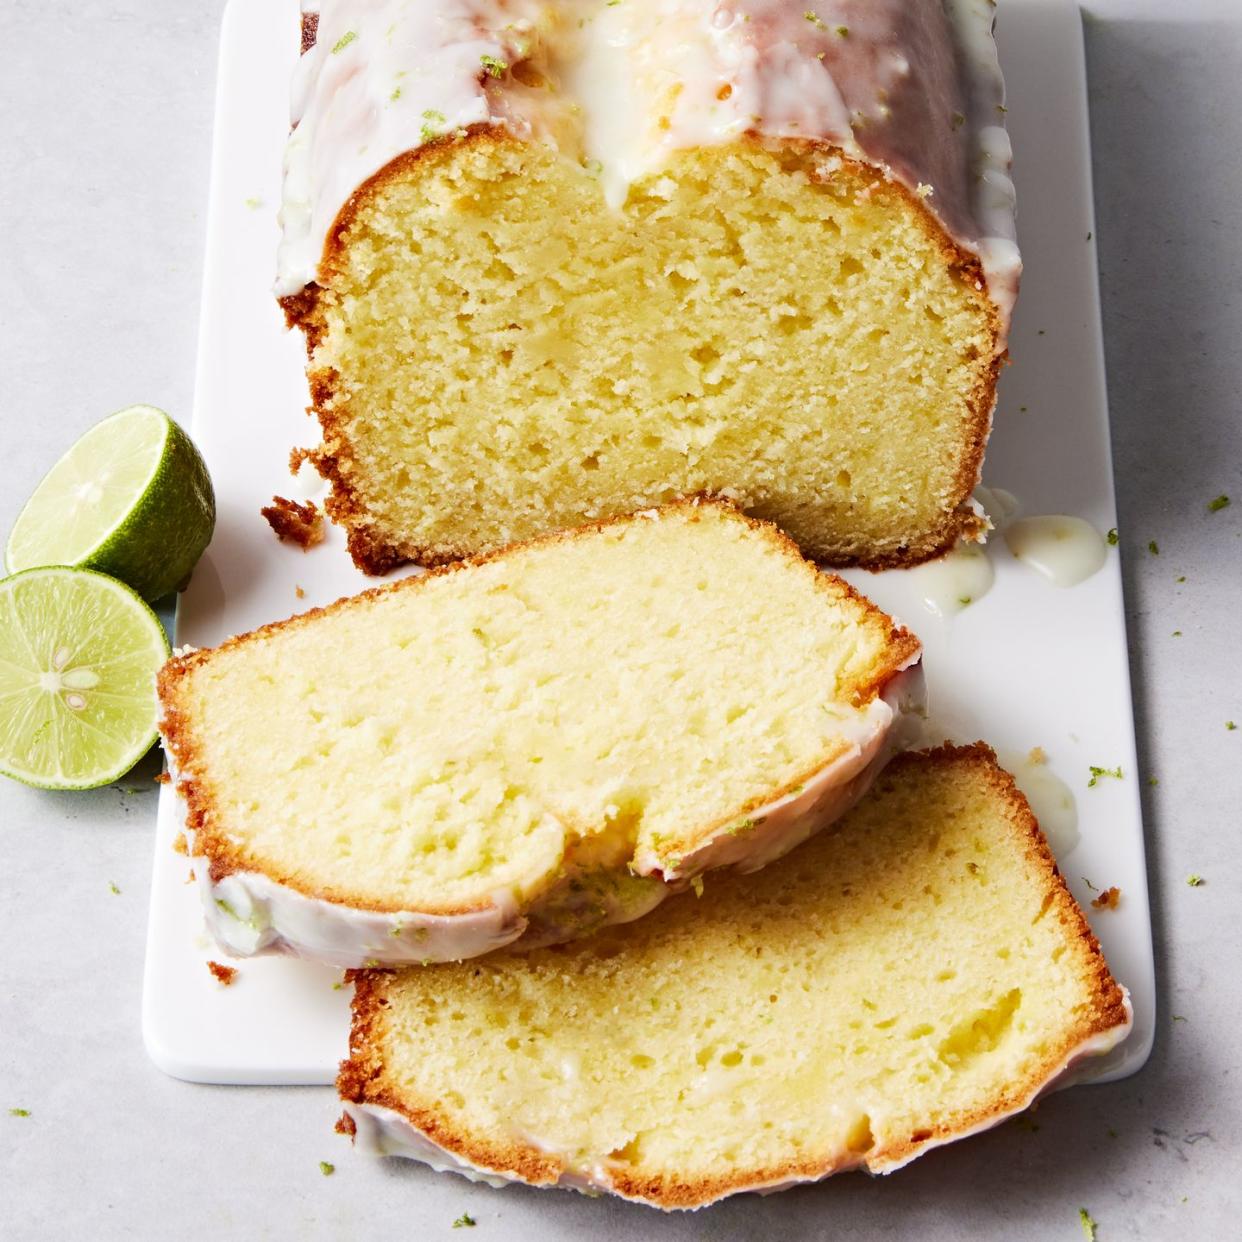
[[345, 987, 1134, 1201]]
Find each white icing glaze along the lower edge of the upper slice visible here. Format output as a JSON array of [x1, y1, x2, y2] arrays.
[[186, 656, 924, 966]]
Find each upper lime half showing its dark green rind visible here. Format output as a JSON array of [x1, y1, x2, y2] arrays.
[[5, 405, 216, 600]]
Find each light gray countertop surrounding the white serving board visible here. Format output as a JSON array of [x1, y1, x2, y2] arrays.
[[0, 0, 1242, 1242]]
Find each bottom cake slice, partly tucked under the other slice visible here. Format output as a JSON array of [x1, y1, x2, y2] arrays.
[[337, 744, 1130, 1208]]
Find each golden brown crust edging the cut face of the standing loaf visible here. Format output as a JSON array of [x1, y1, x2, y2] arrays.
[[281, 124, 1007, 576]]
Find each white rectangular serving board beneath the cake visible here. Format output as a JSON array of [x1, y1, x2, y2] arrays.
[[143, 0, 1155, 1083]]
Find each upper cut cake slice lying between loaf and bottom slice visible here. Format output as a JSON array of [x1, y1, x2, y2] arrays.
[[159, 502, 922, 966]]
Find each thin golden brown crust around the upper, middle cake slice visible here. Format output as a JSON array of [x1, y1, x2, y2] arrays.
[[156, 497, 922, 915]]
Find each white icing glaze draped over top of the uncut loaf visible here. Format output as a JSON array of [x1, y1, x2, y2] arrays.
[[277, 0, 1021, 348]]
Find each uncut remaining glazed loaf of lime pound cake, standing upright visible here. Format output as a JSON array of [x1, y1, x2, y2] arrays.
[[277, 0, 1020, 573]]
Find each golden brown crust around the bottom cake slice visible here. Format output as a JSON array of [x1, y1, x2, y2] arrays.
[[337, 741, 1129, 1208]]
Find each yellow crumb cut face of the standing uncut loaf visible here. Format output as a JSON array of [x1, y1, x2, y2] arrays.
[[306, 139, 995, 570]]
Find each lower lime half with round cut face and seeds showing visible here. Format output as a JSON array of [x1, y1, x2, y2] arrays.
[[0, 566, 169, 789]]
